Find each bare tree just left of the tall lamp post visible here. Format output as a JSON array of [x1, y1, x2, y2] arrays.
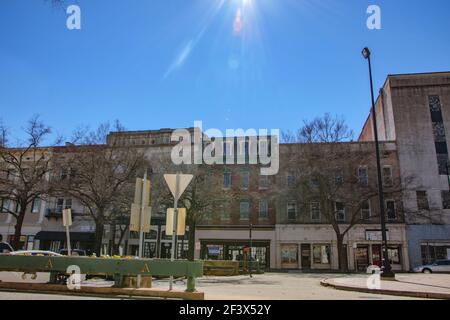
[[285, 114, 405, 271]]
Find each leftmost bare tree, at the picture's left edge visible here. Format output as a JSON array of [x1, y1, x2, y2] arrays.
[[0, 116, 60, 249]]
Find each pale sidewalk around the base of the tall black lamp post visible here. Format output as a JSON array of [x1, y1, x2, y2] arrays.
[[321, 274, 450, 300]]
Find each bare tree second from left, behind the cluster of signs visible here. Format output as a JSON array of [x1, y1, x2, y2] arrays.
[[55, 123, 146, 255]]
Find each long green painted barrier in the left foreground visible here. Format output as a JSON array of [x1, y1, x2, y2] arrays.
[[0, 255, 203, 292]]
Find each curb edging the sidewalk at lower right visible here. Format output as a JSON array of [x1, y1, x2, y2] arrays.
[[320, 278, 450, 300]]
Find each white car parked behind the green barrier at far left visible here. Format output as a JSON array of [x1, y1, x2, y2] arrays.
[[0, 250, 62, 283]]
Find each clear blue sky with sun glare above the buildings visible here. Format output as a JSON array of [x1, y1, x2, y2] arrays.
[[0, 0, 450, 142]]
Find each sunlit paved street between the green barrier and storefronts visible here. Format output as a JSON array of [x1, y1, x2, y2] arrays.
[[0, 273, 450, 300]]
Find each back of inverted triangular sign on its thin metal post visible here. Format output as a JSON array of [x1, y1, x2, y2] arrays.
[[164, 173, 194, 290]]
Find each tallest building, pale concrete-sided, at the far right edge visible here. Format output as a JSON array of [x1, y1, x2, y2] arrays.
[[360, 72, 450, 267]]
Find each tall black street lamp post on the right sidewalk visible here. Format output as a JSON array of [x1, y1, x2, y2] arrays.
[[362, 47, 395, 279]]
